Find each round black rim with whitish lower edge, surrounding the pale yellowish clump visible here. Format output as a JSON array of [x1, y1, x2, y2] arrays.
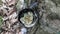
[[18, 8, 38, 27]]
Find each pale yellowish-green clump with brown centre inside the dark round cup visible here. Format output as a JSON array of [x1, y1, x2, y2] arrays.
[[20, 12, 33, 25]]
